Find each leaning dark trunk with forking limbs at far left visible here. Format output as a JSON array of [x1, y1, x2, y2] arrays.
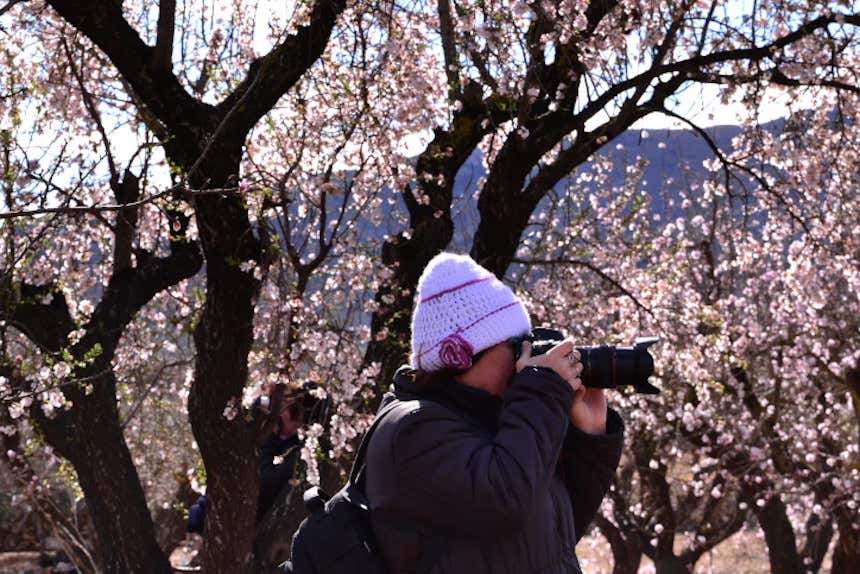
[[12, 258, 201, 573]]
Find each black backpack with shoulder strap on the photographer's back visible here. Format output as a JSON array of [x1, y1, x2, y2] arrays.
[[283, 400, 435, 574]]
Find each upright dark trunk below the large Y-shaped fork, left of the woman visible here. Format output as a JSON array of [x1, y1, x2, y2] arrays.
[[188, 152, 261, 574]]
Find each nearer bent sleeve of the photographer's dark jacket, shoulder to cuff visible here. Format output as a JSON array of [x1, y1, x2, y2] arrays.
[[380, 368, 573, 536]]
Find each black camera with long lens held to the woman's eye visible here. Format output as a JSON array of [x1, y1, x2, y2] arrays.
[[514, 327, 660, 395]]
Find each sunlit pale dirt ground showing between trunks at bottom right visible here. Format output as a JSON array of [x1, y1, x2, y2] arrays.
[[576, 531, 833, 574]]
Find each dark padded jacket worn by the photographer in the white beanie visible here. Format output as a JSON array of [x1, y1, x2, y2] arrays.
[[366, 367, 623, 574]]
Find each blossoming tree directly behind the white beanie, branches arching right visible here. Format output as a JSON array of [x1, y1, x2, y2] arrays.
[[367, 0, 860, 390]]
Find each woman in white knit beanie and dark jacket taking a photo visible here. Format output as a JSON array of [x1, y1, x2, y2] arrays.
[[366, 253, 623, 574]]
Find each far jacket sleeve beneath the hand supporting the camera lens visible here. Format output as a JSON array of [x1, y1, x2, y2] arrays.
[[560, 409, 624, 542]]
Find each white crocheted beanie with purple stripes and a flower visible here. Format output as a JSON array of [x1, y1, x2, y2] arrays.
[[412, 253, 531, 371]]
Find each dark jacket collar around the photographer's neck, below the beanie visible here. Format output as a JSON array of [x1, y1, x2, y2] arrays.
[[385, 366, 503, 430]]
